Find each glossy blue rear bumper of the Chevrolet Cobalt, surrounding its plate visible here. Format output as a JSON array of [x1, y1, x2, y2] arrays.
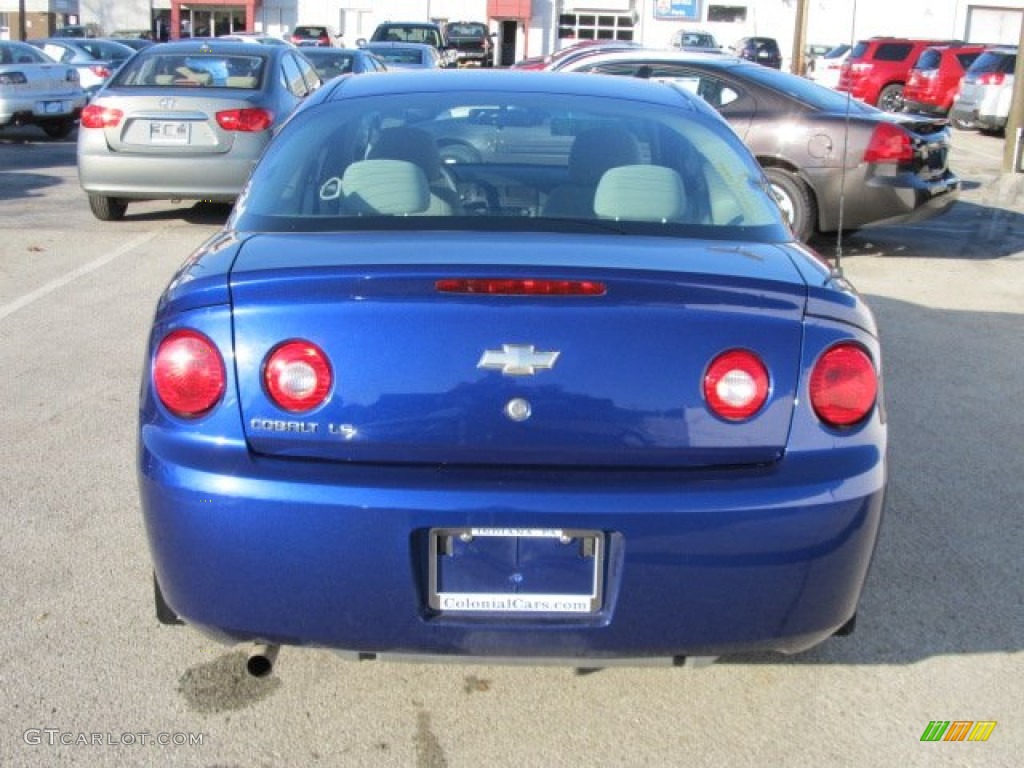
[[139, 426, 885, 658]]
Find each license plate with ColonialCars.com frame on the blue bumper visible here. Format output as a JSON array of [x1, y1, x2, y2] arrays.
[[430, 528, 604, 615]]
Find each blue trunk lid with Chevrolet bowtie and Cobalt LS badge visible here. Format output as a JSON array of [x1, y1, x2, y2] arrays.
[[231, 234, 805, 467]]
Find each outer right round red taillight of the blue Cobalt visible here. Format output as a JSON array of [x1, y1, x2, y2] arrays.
[[810, 342, 879, 427]]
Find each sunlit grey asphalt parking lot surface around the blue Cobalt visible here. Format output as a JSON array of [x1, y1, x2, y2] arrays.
[[0, 123, 1024, 768]]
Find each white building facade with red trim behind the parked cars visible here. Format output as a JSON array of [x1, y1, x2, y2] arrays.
[[0, 0, 1024, 70]]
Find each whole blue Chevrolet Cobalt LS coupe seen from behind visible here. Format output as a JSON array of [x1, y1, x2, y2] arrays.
[[138, 71, 887, 666]]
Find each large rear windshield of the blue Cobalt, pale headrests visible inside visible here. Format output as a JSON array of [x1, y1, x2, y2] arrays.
[[229, 84, 792, 242]]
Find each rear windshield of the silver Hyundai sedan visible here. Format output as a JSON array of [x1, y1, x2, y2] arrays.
[[113, 53, 266, 90]]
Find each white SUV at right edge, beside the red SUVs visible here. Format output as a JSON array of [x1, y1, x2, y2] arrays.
[[949, 46, 1017, 132]]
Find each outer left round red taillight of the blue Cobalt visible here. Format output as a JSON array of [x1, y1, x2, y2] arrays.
[[153, 329, 225, 419]]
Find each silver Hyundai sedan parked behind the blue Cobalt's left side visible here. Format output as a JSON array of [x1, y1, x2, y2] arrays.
[[78, 40, 321, 221]]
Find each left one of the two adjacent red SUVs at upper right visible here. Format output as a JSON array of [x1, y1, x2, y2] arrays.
[[837, 37, 962, 112]]
